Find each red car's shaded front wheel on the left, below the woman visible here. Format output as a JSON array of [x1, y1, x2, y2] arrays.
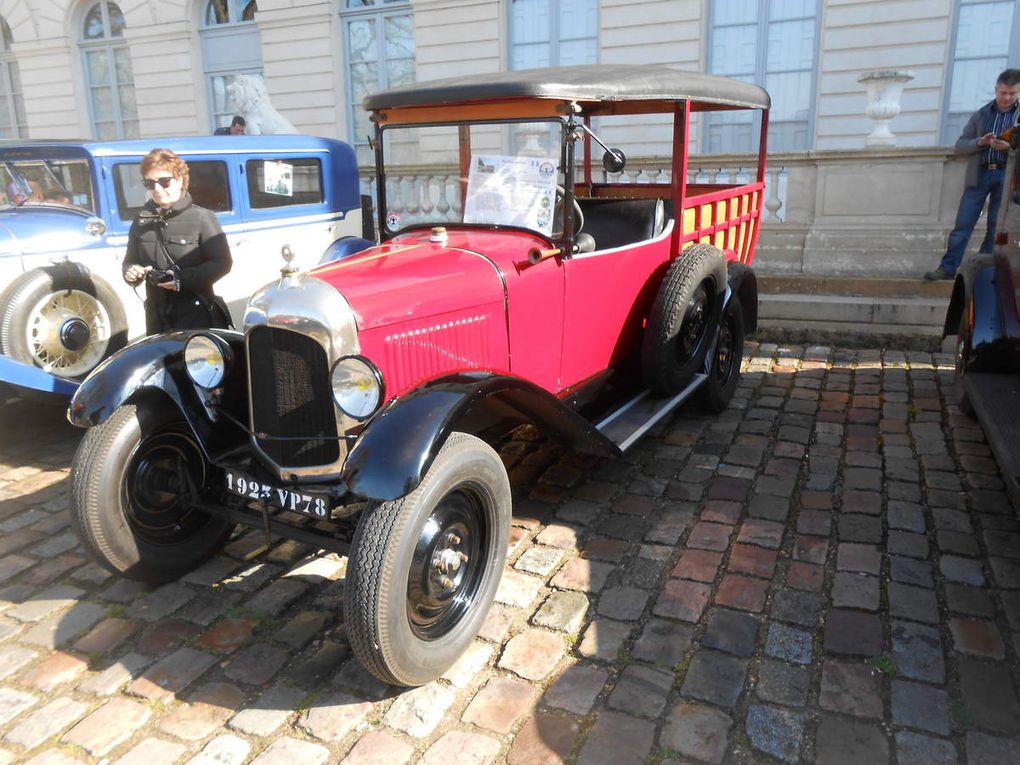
[[70, 405, 234, 583]]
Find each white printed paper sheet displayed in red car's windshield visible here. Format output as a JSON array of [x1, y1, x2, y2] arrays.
[[464, 154, 556, 236]]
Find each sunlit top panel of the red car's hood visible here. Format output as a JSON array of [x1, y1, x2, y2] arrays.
[[310, 237, 506, 332]]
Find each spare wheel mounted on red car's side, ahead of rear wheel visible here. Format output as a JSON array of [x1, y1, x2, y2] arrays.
[[641, 244, 726, 396]]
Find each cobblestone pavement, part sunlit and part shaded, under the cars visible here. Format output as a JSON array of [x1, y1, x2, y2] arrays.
[[0, 344, 1020, 765]]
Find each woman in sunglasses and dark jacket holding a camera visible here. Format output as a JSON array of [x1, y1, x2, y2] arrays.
[[123, 149, 232, 335]]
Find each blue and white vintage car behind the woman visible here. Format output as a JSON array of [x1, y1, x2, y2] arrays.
[[0, 136, 367, 393]]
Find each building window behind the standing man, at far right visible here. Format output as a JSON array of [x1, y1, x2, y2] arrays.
[[942, 0, 1020, 144]]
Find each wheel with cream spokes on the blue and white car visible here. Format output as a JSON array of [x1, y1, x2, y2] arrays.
[[0, 263, 128, 379]]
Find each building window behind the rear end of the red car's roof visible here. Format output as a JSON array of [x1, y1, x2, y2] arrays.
[[703, 0, 818, 152]]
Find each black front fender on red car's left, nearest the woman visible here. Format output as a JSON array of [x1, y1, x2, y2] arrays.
[[67, 329, 247, 456]]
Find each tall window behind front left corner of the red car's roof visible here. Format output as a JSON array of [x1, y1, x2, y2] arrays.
[[341, 0, 414, 164]]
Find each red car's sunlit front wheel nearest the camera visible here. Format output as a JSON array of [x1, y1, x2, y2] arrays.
[[344, 432, 512, 685]]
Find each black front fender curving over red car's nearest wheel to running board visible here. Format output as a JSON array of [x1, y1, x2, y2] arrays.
[[342, 371, 620, 501]]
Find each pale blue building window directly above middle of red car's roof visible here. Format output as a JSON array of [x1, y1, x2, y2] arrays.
[[510, 0, 599, 69]]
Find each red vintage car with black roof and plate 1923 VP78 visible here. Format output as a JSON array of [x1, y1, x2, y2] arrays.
[[69, 66, 769, 685]]
